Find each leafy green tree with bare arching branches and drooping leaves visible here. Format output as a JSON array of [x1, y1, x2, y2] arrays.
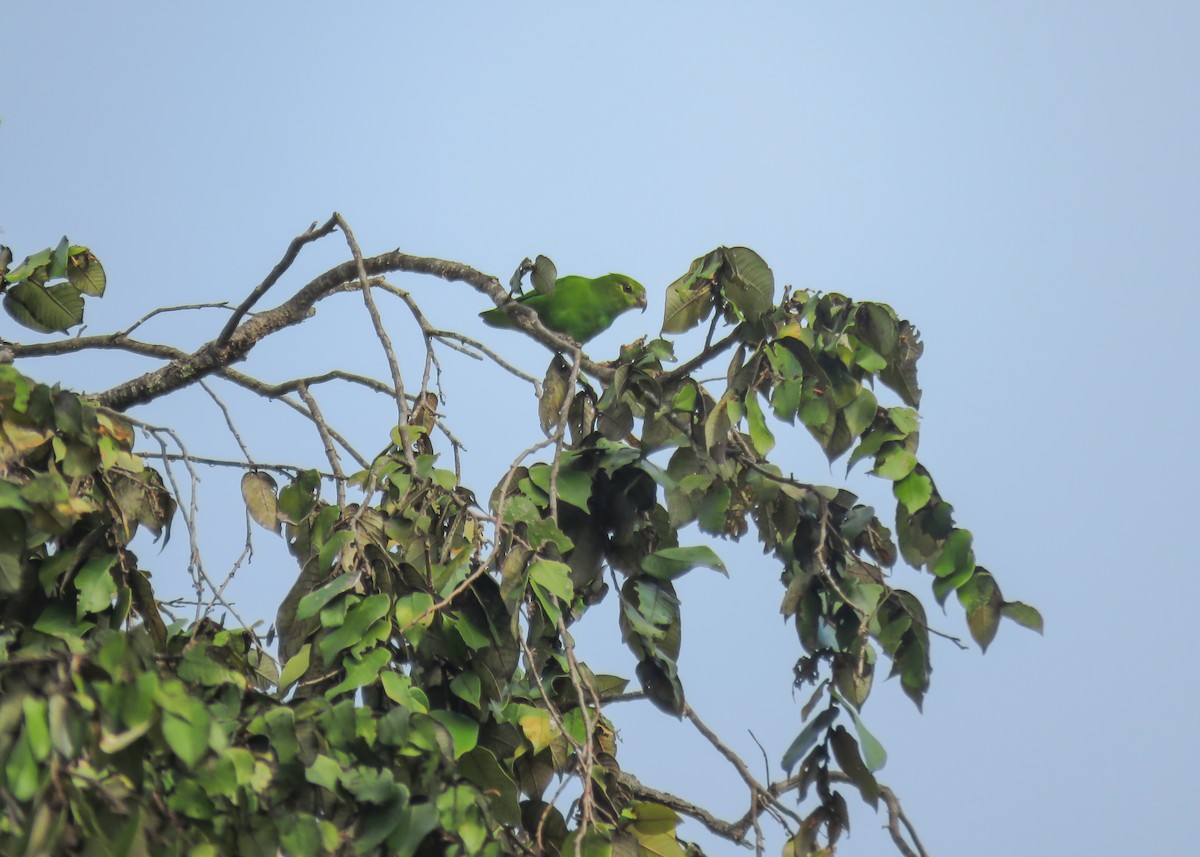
[[0, 222, 1040, 857]]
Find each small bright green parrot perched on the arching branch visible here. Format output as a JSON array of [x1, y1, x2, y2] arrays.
[[479, 274, 646, 343]]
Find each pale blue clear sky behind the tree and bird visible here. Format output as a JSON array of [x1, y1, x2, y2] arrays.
[[0, 0, 1200, 857]]
